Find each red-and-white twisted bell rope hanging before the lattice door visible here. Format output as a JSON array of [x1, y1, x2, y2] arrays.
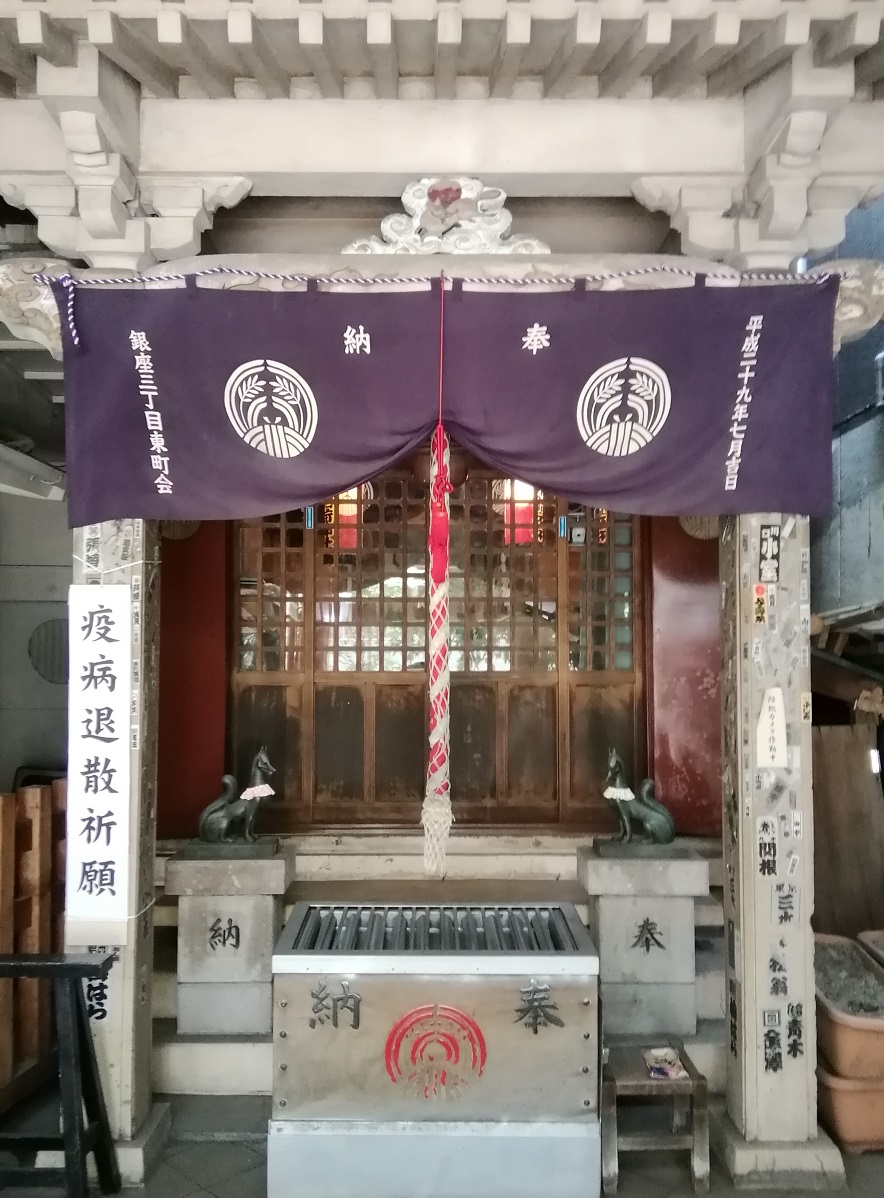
[[420, 434, 454, 878]]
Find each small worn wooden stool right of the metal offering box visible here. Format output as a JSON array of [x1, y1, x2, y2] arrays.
[[601, 1037, 709, 1194]]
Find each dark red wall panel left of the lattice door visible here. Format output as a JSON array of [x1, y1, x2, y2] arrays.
[[157, 521, 229, 837]]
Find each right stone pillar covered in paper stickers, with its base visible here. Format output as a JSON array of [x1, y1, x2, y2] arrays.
[[714, 513, 843, 1187]]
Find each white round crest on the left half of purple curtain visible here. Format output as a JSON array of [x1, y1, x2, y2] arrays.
[[224, 358, 319, 458]]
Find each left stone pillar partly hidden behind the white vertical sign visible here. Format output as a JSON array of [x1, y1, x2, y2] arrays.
[[66, 520, 169, 1185]]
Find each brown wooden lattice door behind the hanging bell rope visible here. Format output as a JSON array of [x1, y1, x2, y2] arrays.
[[232, 457, 643, 830]]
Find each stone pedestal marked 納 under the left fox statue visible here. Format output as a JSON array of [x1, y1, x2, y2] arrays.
[[165, 845, 293, 1036]]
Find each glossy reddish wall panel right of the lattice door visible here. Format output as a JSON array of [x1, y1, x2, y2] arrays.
[[647, 519, 721, 836]]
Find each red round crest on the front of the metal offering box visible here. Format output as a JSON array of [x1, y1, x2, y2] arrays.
[[383, 1004, 488, 1101]]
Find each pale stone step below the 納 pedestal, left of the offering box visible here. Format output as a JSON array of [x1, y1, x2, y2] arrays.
[[153, 1019, 273, 1094]]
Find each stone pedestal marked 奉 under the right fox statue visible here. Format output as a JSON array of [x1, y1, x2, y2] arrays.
[[577, 843, 709, 1035]]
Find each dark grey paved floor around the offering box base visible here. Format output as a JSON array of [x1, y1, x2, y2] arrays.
[[0, 1096, 884, 1198]]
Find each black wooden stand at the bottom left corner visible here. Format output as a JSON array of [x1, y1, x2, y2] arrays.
[[0, 952, 121, 1198]]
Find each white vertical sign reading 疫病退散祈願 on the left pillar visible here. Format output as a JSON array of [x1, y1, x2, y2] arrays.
[[65, 585, 132, 944]]
